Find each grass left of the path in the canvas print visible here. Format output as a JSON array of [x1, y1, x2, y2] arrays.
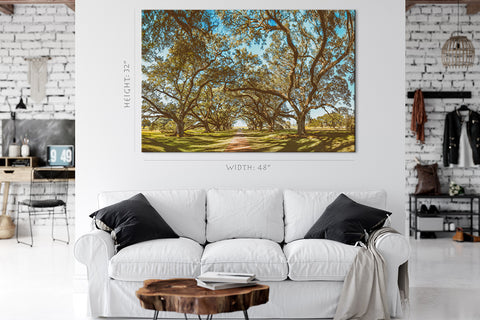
[[142, 130, 237, 152]]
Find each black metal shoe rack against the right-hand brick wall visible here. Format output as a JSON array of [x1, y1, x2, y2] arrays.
[[409, 194, 480, 239]]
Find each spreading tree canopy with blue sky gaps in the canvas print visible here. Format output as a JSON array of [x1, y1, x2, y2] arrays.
[[142, 10, 355, 136]]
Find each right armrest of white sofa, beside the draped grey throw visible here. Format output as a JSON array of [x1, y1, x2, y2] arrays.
[[375, 233, 410, 317]]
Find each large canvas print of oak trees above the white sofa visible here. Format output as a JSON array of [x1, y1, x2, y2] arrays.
[[141, 10, 355, 152]]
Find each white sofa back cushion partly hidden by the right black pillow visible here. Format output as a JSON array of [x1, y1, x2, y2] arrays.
[[284, 190, 387, 243]]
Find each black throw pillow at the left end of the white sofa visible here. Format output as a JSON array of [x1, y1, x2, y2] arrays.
[[90, 193, 178, 252]]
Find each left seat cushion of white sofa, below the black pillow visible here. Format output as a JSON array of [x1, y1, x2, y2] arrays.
[[108, 238, 203, 281]]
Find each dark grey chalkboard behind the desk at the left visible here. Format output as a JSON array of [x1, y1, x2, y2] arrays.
[[2, 120, 75, 165]]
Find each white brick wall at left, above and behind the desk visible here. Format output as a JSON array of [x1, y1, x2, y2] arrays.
[[0, 5, 75, 223]]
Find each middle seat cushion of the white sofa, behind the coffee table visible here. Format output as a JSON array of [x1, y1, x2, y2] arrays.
[[201, 239, 288, 281]]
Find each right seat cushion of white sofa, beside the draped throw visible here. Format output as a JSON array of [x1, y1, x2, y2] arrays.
[[283, 239, 360, 281]]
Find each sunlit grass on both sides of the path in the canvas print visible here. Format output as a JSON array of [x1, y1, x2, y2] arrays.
[[142, 129, 355, 152]]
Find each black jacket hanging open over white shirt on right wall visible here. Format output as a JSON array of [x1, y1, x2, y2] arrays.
[[443, 110, 480, 167]]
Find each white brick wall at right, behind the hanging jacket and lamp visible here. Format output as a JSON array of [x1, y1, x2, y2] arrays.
[[405, 5, 480, 230]]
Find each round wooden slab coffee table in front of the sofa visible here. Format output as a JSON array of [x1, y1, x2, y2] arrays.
[[135, 279, 269, 320]]
